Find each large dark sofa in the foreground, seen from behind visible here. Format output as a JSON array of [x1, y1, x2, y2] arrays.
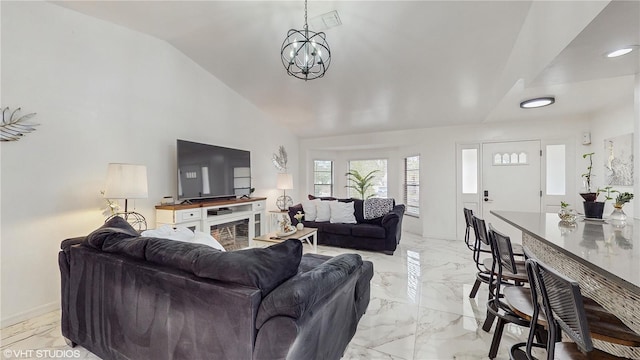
[[58, 218, 373, 360]]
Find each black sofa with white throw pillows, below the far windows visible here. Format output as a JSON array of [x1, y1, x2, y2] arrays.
[[289, 195, 405, 255]]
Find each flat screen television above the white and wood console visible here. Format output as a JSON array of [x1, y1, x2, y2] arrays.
[[176, 140, 251, 201]]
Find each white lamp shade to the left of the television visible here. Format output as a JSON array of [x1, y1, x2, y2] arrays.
[[104, 163, 148, 199]]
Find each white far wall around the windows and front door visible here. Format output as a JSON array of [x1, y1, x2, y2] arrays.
[[300, 118, 590, 239]]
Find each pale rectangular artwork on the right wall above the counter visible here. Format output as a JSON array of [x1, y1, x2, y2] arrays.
[[604, 134, 633, 186]]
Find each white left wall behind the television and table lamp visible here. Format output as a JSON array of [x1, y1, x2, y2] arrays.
[[0, 2, 299, 326]]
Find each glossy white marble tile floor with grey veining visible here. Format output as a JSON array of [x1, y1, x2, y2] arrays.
[[0, 233, 528, 360]]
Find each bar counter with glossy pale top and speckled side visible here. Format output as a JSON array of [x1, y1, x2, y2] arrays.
[[491, 211, 640, 359]]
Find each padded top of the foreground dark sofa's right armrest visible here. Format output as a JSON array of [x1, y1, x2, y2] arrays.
[[256, 254, 362, 329]]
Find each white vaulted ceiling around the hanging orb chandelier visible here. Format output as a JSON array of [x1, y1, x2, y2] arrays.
[[55, 0, 640, 137]]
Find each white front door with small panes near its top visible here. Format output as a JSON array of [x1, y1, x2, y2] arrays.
[[480, 140, 542, 243]]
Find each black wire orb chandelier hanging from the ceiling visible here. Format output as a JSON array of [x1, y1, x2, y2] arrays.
[[280, 0, 331, 81]]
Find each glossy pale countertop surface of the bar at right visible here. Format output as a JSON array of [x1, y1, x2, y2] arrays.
[[491, 211, 640, 293]]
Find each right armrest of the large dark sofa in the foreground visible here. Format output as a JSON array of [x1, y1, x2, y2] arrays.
[[253, 254, 368, 360]]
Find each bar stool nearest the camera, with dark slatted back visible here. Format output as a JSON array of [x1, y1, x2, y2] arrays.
[[510, 259, 640, 360]]
